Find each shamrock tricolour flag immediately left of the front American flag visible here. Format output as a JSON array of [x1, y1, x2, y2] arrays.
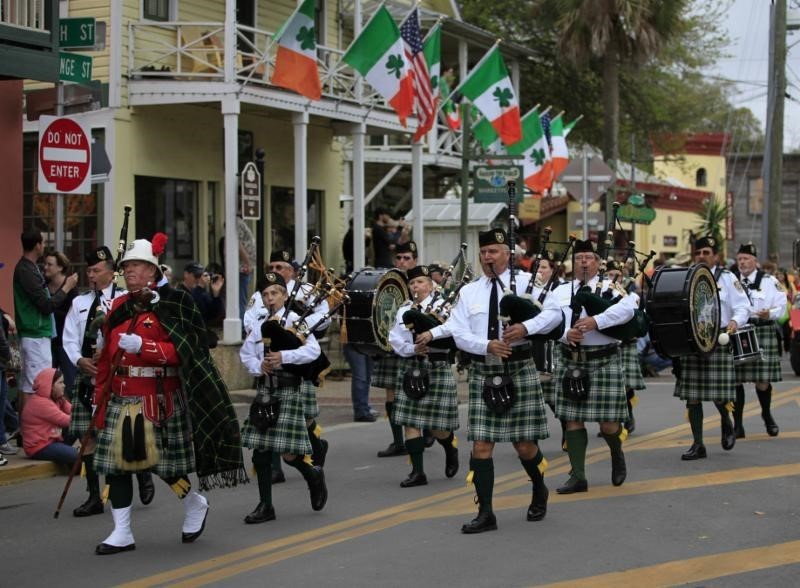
[[342, 5, 414, 126]]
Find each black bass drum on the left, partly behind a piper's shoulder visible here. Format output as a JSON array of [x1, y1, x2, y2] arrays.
[[344, 268, 411, 355]]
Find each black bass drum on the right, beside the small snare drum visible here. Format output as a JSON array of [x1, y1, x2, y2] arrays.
[[647, 264, 720, 358]]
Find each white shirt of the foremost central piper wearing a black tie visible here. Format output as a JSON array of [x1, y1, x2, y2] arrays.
[[444, 269, 562, 355]]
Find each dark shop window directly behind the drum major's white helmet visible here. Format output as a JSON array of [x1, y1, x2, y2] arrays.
[[133, 176, 197, 270]]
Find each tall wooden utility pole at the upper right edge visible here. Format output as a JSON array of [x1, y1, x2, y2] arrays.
[[761, 0, 786, 259]]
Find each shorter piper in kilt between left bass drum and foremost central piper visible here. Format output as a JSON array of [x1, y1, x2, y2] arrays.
[[389, 265, 459, 488]]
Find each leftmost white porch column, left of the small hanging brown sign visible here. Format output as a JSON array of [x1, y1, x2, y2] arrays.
[[222, 97, 242, 343]]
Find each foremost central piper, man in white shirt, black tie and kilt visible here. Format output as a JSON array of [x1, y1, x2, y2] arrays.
[[447, 229, 562, 533]]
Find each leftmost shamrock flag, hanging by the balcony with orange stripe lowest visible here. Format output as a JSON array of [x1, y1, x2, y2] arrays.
[[270, 0, 322, 100]]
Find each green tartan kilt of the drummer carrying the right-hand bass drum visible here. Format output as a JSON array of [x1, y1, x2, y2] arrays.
[[673, 345, 736, 402]]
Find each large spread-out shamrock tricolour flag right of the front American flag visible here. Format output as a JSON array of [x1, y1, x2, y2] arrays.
[[458, 45, 522, 145]]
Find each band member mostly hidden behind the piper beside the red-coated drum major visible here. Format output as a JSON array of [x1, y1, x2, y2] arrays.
[[244, 249, 330, 484]]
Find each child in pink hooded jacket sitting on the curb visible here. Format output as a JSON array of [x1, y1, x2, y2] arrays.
[[22, 368, 78, 465]]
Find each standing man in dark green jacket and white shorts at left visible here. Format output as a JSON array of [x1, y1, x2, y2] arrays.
[[14, 229, 78, 420]]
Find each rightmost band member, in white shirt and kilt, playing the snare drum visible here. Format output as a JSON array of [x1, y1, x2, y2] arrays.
[[733, 243, 786, 439]]
